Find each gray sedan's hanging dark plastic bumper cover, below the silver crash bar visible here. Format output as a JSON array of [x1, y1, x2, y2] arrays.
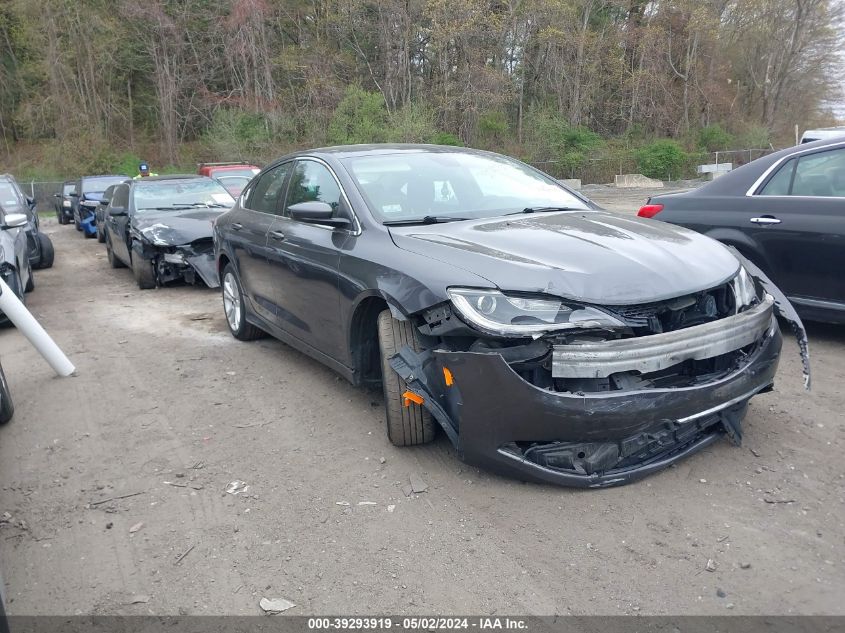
[[391, 317, 782, 487]]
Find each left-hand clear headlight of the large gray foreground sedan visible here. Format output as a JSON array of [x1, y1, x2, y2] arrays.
[[447, 288, 624, 336]]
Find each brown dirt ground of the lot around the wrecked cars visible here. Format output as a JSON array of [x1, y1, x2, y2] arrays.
[[0, 204, 845, 614]]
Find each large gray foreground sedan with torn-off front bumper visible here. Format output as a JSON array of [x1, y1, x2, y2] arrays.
[[214, 145, 809, 487]]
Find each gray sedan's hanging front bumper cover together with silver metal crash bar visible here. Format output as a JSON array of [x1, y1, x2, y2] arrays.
[[391, 297, 782, 487]]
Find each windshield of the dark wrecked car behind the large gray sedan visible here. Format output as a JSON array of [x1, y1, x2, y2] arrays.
[[132, 178, 235, 212]]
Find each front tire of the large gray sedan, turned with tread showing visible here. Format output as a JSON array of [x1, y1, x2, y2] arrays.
[[378, 310, 436, 446]]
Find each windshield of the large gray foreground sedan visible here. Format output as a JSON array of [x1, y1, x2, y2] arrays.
[[343, 152, 589, 222]]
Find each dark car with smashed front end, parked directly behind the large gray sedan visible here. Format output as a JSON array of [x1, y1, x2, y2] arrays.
[[102, 175, 235, 290]]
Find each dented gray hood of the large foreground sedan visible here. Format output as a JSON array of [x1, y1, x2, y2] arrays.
[[390, 211, 739, 305]]
